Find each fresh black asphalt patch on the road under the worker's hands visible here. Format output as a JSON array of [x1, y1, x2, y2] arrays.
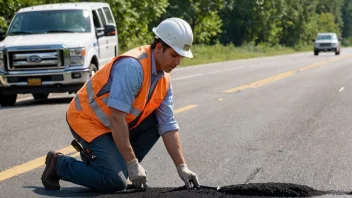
[[112, 183, 332, 198]]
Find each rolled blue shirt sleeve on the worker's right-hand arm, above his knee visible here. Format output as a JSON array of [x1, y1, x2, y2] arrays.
[[156, 82, 180, 135]]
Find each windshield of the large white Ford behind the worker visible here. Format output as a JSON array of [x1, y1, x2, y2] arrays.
[[8, 10, 91, 35]]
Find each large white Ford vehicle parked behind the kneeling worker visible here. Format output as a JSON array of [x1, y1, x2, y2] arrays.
[[0, 2, 118, 106]]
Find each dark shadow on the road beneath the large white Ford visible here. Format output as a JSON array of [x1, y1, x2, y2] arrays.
[[0, 97, 73, 110]]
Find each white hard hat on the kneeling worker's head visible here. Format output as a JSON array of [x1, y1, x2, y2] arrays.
[[153, 18, 193, 58]]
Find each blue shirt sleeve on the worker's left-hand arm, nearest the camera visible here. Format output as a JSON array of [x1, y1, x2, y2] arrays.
[[108, 58, 143, 113]]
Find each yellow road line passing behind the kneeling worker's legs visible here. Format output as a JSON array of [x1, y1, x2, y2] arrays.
[[0, 105, 198, 182]]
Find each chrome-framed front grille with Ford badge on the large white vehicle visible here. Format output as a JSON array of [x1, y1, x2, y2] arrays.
[[6, 46, 69, 71]]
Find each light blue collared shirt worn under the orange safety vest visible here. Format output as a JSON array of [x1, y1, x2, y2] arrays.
[[104, 50, 179, 135]]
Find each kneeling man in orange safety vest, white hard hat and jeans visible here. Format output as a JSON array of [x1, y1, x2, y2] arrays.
[[41, 18, 200, 193]]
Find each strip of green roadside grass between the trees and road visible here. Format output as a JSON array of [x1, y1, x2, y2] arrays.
[[119, 44, 313, 67]]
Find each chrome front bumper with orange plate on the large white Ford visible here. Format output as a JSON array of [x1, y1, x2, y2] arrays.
[[0, 69, 90, 94]]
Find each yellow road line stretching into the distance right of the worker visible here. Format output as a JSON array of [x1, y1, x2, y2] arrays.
[[223, 55, 352, 93]]
